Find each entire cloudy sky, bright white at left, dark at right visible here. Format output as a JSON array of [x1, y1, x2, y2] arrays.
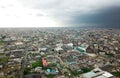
[[0, 0, 120, 27]]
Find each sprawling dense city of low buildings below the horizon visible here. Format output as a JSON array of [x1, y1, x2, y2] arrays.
[[0, 27, 120, 78]]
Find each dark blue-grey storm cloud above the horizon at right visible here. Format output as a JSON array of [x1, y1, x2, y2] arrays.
[[70, 7, 120, 26]]
